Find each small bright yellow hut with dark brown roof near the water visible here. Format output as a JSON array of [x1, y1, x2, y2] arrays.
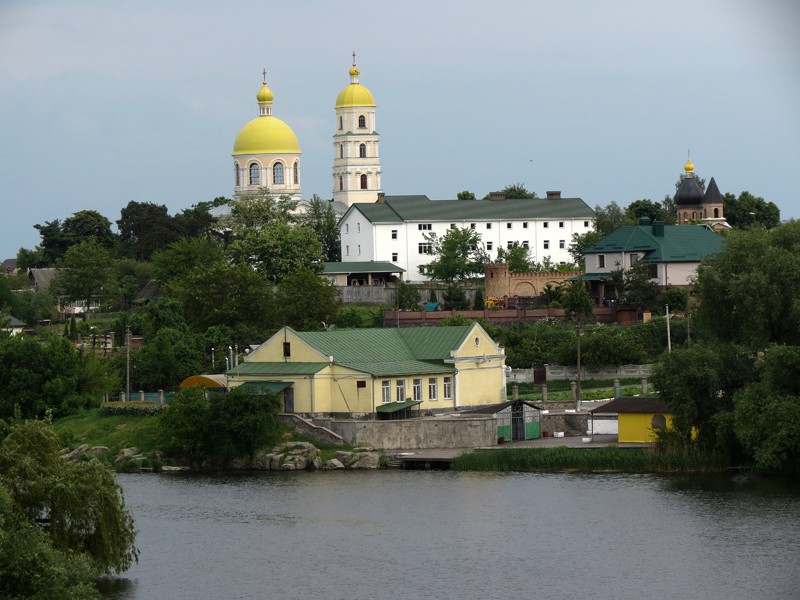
[[591, 396, 672, 443]]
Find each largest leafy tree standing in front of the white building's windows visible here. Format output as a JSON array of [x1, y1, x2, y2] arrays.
[[420, 228, 488, 282]]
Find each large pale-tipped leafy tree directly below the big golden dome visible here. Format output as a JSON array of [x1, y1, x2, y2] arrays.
[[222, 188, 325, 283]]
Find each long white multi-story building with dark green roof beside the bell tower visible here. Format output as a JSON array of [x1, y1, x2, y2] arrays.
[[339, 192, 594, 281]]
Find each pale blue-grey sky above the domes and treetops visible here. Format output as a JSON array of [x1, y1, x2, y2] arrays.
[[0, 0, 800, 259]]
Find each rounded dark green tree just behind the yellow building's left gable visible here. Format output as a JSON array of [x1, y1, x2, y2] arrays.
[[276, 269, 342, 331]]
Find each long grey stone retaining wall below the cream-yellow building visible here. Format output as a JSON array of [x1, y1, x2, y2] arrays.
[[315, 417, 497, 450]]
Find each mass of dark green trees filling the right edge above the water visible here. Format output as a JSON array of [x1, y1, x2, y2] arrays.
[[653, 221, 800, 474]]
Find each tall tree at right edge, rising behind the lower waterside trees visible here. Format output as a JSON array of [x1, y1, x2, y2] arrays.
[[695, 221, 800, 349]]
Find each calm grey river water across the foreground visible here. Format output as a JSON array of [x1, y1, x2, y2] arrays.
[[103, 470, 800, 600]]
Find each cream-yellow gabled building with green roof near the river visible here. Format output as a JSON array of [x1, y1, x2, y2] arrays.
[[228, 323, 506, 418]]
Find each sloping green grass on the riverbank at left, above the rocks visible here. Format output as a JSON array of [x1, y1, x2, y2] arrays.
[[53, 408, 160, 458]]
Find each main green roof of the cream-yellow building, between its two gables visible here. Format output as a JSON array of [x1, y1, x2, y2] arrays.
[[295, 325, 473, 375]]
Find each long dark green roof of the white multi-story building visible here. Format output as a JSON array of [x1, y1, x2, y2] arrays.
[[348, 196, 594, 223]]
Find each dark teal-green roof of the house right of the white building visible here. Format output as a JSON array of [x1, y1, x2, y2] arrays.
[[584, 225, 725, 263]]
